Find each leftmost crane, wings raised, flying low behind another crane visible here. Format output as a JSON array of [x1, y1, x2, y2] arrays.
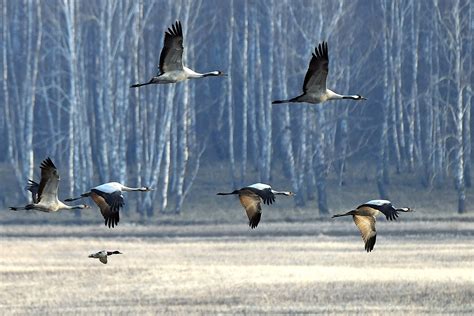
[[10, 157, 89, 213]]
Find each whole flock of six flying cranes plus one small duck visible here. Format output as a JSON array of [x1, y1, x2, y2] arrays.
[[10, 21, 412, 264]]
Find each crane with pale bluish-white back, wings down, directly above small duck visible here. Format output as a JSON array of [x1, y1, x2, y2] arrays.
[[65, 182, 152, 228]]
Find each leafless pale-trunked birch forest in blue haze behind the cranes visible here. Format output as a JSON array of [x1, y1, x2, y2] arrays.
[[0, 0, 474, 218]]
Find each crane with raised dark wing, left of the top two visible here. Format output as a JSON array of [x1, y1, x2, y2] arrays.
[[130, 21, 225, 88]]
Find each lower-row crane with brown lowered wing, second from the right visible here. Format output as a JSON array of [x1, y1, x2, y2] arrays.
[[217, 183, 295, 229]]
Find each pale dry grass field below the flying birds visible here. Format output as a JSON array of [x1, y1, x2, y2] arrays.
[[0, 216, 474, 315]]
